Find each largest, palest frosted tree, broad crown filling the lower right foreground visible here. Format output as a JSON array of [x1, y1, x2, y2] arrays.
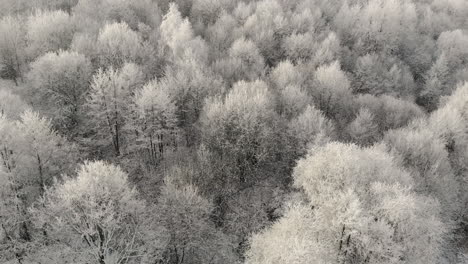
[[247, 143, 447, 264]]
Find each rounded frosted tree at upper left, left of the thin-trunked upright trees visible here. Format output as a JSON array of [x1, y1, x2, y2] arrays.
[[28, 51, 91, 131]]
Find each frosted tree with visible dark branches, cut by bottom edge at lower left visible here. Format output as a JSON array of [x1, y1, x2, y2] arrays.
[[30, 161, 151, 264]]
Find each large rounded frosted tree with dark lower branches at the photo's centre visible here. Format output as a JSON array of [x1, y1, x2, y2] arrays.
[[201, 81, 278, 186]]
